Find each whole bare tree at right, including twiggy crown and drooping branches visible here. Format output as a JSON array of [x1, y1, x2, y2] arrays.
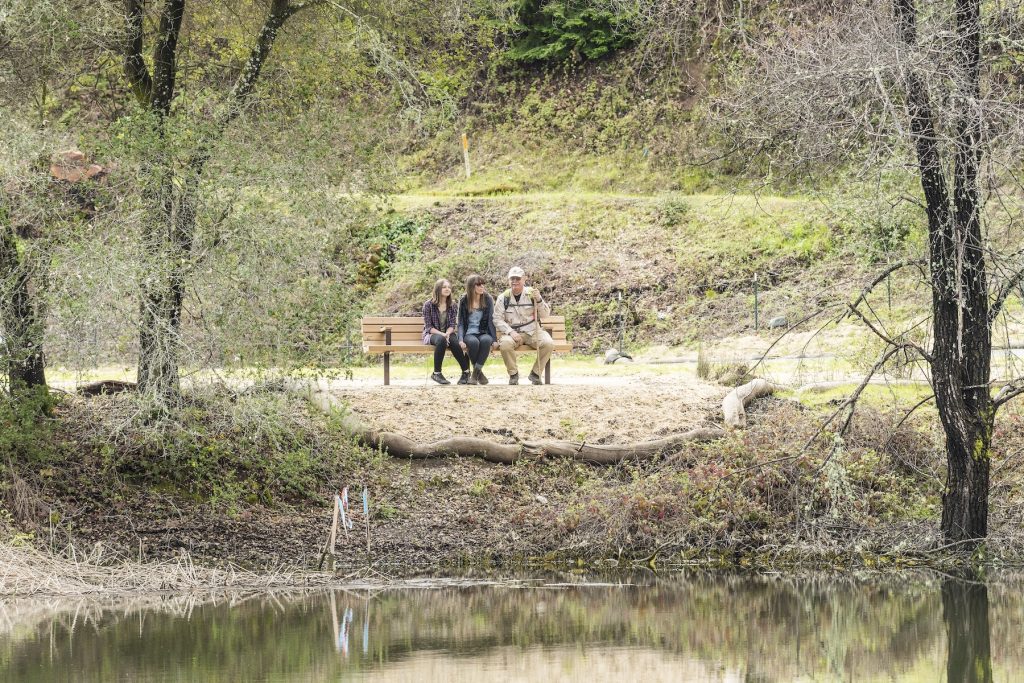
[[710, 0, 1024, 549]]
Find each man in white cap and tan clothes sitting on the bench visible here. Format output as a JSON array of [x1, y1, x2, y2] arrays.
[[495, 265, 555, 384]]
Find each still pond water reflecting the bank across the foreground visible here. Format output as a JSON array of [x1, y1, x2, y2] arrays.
[[0, 575, 1024, 683]]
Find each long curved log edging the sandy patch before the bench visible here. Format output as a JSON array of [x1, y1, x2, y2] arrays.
[[307, 390, 725, 465]]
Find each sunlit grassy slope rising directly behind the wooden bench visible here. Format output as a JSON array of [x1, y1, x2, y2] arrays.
[[368, 189, 888, 351]]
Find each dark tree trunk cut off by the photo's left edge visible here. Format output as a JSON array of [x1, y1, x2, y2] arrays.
[[0, 197, 46, 393]]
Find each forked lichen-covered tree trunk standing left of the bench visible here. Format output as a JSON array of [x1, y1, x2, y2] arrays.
[[116, 0, 333, 407]]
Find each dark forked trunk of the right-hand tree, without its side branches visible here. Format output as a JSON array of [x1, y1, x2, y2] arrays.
[[894, 0, 994, 547]]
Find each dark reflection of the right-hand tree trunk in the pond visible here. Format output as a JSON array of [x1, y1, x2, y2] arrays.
[[942, 579, 992, 683]]
